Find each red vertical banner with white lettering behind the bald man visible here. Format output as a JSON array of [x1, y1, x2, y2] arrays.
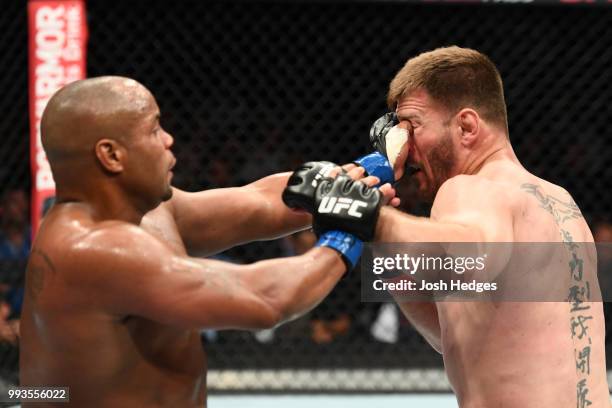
[[28, 0, 87, 234]]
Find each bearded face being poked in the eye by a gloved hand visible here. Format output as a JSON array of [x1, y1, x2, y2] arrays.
[[396, 90, 456, 201]]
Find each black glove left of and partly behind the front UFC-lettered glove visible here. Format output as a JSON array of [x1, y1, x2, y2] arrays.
[[282, 161, 345, 214]]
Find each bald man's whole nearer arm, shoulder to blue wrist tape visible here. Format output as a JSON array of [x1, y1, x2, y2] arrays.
[[79, 223, 346, 329]]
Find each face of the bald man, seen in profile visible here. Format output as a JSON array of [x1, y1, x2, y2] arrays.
[[128, 94, 176, 207]]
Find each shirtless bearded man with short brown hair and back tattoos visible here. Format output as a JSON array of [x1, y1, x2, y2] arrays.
[[286, 47, 610, 408]]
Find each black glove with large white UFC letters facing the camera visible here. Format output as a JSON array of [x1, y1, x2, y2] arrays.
[[312, 175, 382, 241]]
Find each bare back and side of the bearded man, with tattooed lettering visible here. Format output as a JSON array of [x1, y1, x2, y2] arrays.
[[437, 165, 610, 408]]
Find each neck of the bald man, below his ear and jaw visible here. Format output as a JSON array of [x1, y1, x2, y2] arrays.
[[56, 182, 148, 225]]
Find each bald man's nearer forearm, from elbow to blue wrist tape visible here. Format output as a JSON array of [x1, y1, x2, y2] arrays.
[[246, 247, 346, 324]]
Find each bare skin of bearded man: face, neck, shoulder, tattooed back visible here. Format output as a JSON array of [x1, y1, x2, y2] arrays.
[[377, 90, 610, 408]]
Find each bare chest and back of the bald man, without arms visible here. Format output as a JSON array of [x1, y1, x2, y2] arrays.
[[20, 204, 206, 407]]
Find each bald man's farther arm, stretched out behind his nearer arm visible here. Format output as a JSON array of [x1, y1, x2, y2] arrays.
[[169, 173, 312, 256]]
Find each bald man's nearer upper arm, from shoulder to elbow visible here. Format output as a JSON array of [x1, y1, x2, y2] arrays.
[[81, 228, 274, 328]]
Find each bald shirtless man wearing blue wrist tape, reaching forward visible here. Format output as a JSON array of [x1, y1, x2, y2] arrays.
[[20, 77, 394, 407]]
